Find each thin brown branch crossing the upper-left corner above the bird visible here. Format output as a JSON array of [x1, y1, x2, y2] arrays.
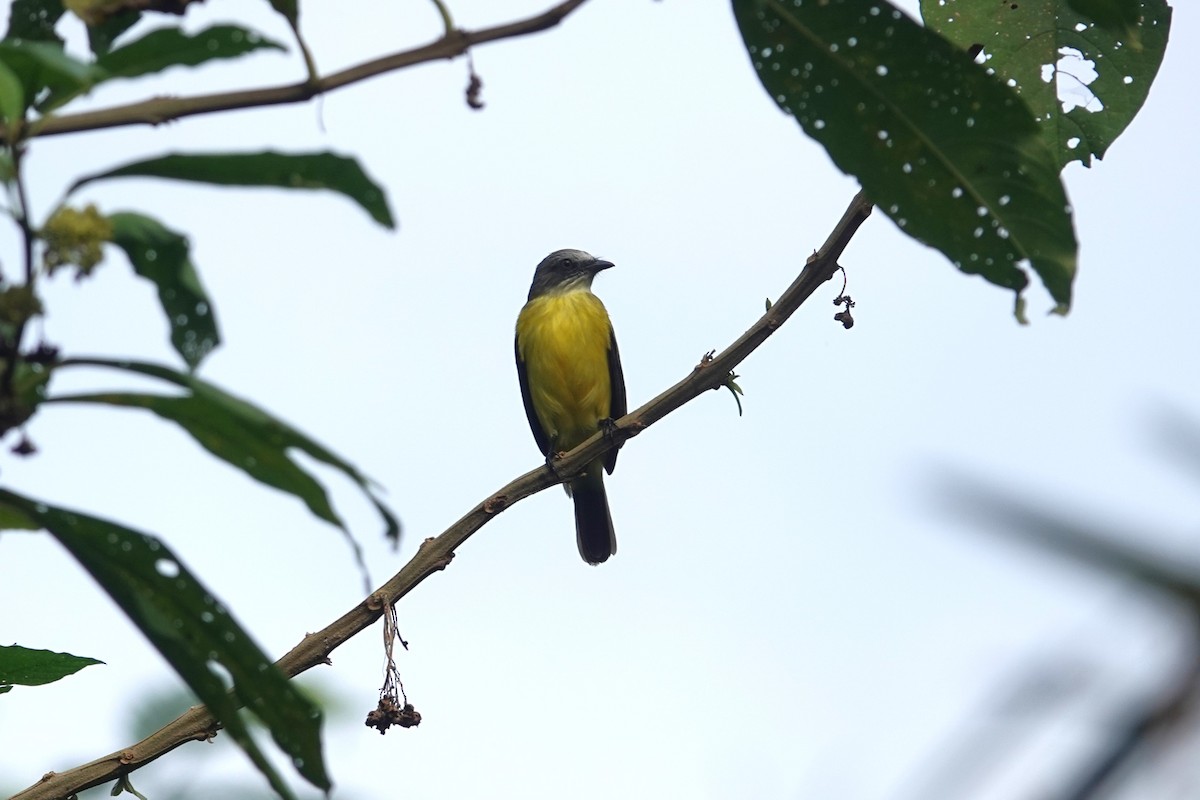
[[8, 0, 586, 143]]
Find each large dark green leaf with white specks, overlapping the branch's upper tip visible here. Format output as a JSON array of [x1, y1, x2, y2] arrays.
[[733, 0, 1076, 312]]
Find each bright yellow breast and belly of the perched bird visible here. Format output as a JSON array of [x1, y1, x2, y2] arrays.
[[517, 289, 612, 450]]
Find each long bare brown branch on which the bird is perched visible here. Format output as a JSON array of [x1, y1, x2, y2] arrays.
[[10, 192, 871, 800]]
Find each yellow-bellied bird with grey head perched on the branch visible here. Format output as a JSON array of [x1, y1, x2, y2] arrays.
[[515, 249, 626, 565]]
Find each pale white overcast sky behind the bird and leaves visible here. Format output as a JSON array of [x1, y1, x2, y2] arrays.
[[0, 0, 1200, 800]]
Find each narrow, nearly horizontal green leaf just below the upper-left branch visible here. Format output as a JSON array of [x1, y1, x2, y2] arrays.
[[71, 151, 396, 228]]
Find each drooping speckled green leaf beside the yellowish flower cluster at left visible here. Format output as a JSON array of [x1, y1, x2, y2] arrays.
[[108, 211, 221, 369]]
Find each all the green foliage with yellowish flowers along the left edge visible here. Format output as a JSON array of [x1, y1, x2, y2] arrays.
[[0, 0, 400, 796]]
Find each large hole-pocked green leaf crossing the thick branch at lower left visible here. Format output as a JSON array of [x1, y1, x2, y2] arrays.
[[0, 489, 330, 798]]
